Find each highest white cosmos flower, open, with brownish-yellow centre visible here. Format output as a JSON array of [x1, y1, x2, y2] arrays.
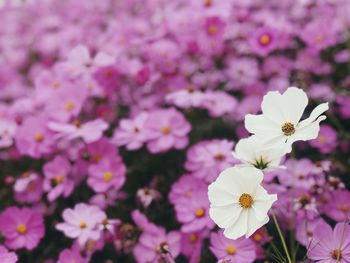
[[245, 87, 328, 150]]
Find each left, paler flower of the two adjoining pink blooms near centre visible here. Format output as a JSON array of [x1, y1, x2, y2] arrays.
[[112, 112, 148, 150]]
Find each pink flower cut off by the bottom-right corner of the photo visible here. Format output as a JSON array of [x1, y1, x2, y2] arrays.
[[307, 223, 350, 263]]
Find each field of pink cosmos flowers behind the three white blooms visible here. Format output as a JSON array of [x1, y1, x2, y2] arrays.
[[0, 0, 350, 263]]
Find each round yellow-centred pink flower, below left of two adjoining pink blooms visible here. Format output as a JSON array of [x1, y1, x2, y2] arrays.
[[87, 158, 126, 193]]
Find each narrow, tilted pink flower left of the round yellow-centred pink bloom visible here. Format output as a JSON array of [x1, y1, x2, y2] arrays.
[[43, 155, 74, 202]]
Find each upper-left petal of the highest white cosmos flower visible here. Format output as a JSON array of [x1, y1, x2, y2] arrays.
[[261, 91, 286, 123]]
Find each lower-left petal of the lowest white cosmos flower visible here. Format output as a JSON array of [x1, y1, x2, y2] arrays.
[[209, 204, 243, 228]]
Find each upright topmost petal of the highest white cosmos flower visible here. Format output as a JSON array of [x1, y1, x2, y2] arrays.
[[281, 87, 308, 124]]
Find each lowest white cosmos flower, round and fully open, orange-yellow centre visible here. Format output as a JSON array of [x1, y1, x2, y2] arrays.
[[208, 167, 277, 239]]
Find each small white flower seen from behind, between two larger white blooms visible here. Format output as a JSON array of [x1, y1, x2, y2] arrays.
[[232, 135, 288, 170]]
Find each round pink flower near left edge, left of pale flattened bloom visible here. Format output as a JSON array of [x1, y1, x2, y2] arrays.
[[15, 117, 54, 159]]
